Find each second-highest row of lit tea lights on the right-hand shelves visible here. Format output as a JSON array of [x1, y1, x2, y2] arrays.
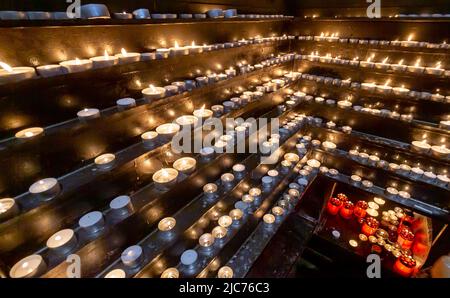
[[298, 51, 450, 77]]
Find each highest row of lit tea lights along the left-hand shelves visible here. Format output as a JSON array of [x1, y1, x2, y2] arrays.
[[0, 35, 293, 84]]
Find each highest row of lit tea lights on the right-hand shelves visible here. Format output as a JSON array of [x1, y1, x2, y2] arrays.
[[297, 32, 450, 49]]
